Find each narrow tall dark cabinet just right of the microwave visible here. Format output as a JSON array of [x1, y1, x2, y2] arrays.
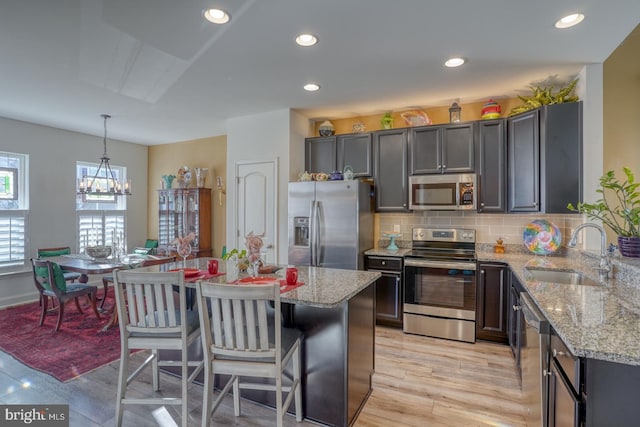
[[476, 119, 507, 213]]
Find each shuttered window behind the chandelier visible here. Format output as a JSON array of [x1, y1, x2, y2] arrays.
[[76, 162, 127, 253]]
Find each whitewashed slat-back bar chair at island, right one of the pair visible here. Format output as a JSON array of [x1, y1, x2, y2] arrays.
[[196, 282, 302, 427]]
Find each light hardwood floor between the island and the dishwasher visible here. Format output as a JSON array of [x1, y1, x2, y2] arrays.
[[355, 327, 526, 427]]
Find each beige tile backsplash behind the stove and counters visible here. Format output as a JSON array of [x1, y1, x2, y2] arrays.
[[375, 211, 586, 247]]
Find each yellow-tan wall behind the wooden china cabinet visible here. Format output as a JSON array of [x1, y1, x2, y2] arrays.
[[147, 136, 227, 257]]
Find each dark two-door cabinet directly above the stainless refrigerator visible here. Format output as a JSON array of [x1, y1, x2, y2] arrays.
[[304, 133, 373, 178]]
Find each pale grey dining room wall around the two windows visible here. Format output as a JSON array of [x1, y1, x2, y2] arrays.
[[0, 117, 147, 307]]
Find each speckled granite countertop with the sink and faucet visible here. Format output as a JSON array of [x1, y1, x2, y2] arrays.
[[477, 250, 640, 365]]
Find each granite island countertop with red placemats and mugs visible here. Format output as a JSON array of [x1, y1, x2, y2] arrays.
[[139, 258, 381, 308]]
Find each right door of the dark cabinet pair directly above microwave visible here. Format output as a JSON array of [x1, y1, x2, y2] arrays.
[[440, 122, 475, 173]]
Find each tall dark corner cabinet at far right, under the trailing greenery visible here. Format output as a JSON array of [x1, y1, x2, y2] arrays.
[[507, 102, 582, 213]]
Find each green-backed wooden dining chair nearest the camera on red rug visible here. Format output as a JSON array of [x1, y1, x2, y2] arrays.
[[31, 258, 100, 331]]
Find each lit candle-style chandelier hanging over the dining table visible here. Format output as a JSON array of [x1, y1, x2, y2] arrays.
[[76, 114, 131, 196]]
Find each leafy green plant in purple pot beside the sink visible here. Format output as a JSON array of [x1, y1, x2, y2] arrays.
[[567, 167, 640, 258]]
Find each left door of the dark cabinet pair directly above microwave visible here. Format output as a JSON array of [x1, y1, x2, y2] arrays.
[[409, 126, 442, 175]]
